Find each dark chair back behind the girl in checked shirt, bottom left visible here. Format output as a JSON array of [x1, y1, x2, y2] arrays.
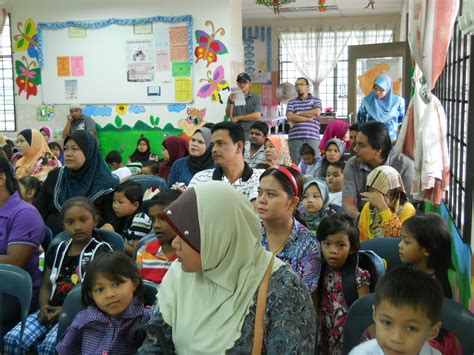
[[57, 280, 159, 341]]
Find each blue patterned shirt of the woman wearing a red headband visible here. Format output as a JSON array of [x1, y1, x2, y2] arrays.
[[260, 218, 321, 292]]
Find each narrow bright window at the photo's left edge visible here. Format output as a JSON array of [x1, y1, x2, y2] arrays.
[[0, 16, 16, 131]]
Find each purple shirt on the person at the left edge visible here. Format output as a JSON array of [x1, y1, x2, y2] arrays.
[[0, 192, 45, 291]]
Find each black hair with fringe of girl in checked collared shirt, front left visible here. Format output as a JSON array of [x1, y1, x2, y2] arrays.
[[81, 251, 143, 307]]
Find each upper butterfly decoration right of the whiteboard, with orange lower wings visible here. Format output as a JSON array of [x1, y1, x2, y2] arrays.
[[194, 20, 228, 67]]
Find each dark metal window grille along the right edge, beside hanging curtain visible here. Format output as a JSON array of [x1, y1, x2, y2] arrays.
[[434, 11, 474, 243]]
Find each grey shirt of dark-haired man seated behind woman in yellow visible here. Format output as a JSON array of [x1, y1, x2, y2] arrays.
[[342, 148, 415, 211]]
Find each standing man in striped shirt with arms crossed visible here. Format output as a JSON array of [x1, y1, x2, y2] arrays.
[[286, 78, 321, 164]]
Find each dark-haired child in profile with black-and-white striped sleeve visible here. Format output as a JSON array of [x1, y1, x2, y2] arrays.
[[102, 180, 151, 256]]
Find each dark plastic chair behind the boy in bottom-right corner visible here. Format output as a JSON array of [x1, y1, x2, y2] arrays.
[[342, 293, 474, 354]]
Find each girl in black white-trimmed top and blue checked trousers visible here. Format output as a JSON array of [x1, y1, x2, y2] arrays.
[[4, 197, 112, 355]]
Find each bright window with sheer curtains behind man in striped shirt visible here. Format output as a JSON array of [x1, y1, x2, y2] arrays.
[[279, 26, 394, 117]]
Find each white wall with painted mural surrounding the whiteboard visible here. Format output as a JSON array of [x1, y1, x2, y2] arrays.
[[8, 0, 243, 159]]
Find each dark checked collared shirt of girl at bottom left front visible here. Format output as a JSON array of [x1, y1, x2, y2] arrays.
[[56, 298, 151, 355]]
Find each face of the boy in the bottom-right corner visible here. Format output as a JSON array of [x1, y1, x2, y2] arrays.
[[373, 300, 441, 355]]
